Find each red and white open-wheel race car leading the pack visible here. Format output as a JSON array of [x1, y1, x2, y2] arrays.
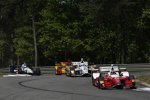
[[92, 65, 136, 89]]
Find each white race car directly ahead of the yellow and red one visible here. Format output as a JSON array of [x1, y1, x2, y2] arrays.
[[66, 59, 90, 77]]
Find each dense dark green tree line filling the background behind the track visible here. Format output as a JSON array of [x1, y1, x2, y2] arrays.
[[0, 0, 150, 67]]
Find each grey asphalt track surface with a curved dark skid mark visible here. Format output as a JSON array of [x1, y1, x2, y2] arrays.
[[0, 75, 150, 100]]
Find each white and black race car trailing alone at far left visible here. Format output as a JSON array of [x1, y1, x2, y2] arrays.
[[10, 63, 41, 75]]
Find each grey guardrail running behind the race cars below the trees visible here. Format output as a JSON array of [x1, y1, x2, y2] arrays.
[[0, 63, 150, 76]]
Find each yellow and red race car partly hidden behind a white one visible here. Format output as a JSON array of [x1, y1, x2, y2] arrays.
[[55, 61, 71, 75]]
